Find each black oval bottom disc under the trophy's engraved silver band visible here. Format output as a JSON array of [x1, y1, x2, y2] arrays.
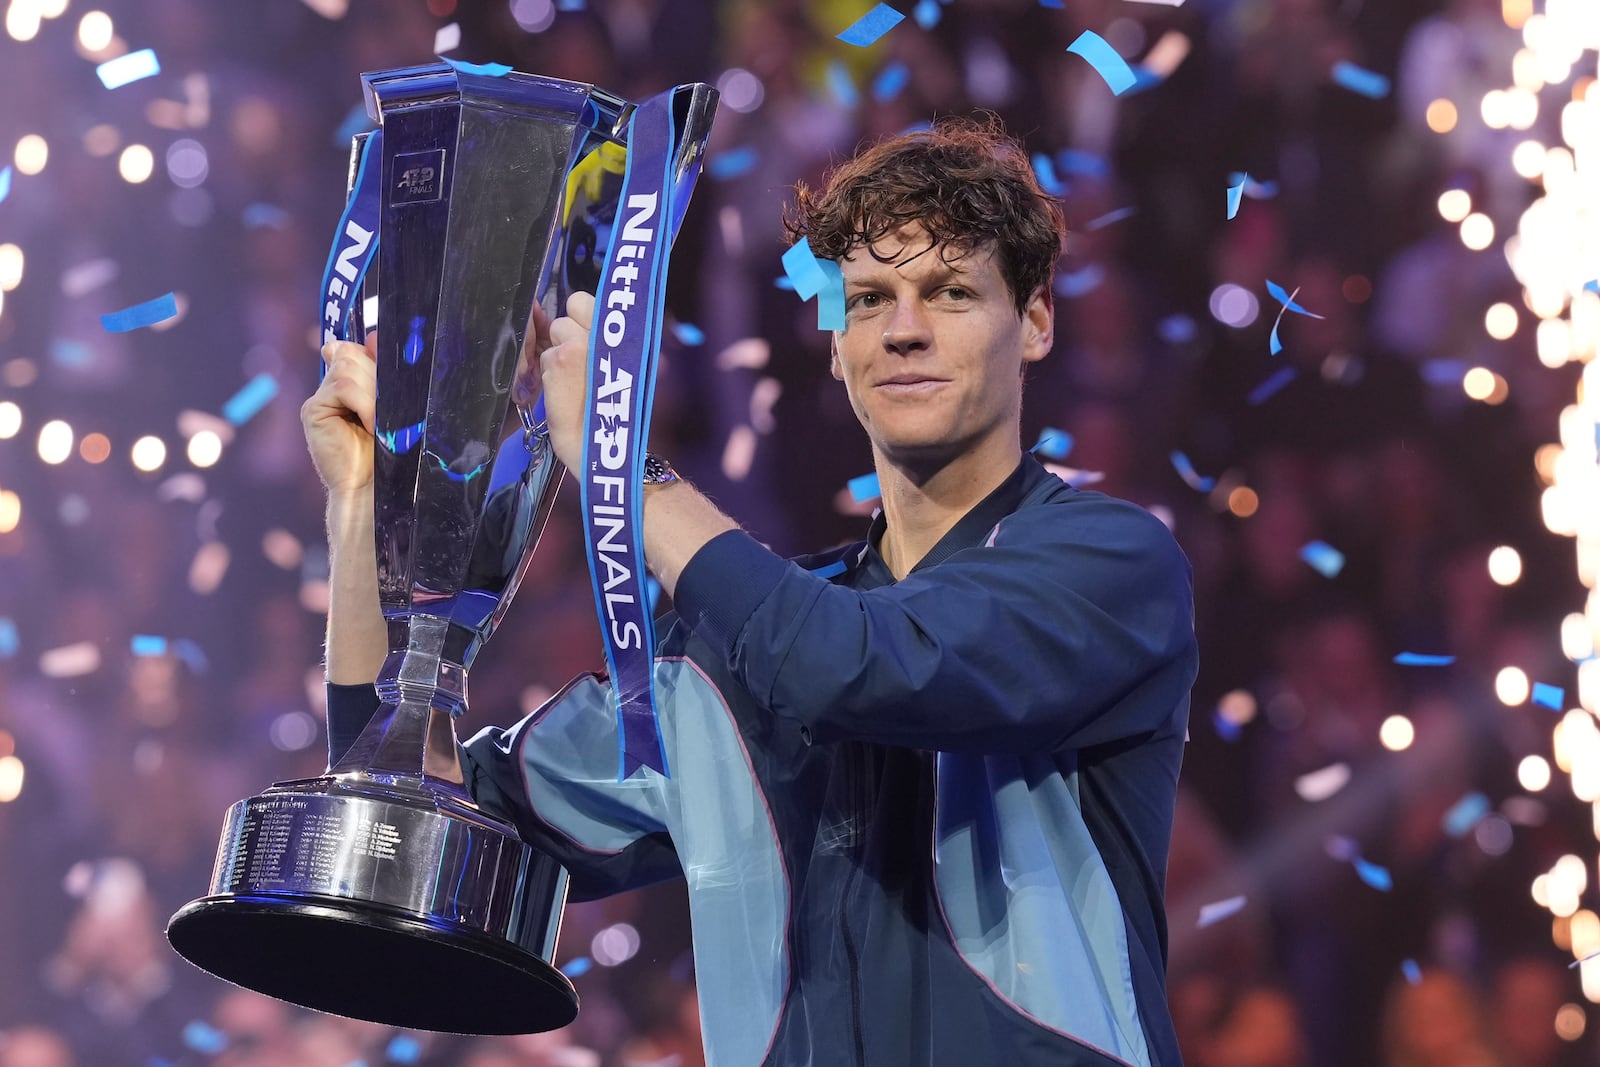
[[166, 896, 578, 1033]]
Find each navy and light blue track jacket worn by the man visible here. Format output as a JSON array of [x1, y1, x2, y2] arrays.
[[330, 456, 1197, 1067]]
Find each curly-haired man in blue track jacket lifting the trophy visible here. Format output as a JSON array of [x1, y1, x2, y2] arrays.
[[304, 123, 1195, 1067]]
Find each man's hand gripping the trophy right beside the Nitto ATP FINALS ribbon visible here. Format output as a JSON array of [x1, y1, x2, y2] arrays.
[[512, 293, 595, 472]]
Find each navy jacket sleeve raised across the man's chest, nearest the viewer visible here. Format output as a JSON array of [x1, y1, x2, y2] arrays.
[[677, 498, 1195, 753]]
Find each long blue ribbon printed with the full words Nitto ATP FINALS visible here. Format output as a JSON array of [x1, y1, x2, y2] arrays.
[[579, 93, 677, 781]]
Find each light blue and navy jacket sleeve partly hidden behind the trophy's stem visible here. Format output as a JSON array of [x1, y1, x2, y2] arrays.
[[328, 675, 682, 901]]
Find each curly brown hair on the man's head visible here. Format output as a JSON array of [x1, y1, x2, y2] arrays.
[[784, 115, 1067, 315]]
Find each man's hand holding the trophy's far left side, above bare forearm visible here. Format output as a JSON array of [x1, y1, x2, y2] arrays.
[[301, 333, 378, 496]]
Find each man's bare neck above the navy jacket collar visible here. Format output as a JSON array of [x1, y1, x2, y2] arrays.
[[874, 445, 1022, 579]]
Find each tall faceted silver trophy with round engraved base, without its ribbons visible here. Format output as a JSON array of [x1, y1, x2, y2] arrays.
[[166, 64, 717, 1033]]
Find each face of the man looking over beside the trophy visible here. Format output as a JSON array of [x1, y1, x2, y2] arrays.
[[832, 226, 1054, 467]]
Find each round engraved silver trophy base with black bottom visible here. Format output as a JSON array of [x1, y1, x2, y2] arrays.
[[166, 774, 578, 1033]]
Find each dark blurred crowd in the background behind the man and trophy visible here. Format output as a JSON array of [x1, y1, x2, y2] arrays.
[[0, 0, 1600, 1067]]
